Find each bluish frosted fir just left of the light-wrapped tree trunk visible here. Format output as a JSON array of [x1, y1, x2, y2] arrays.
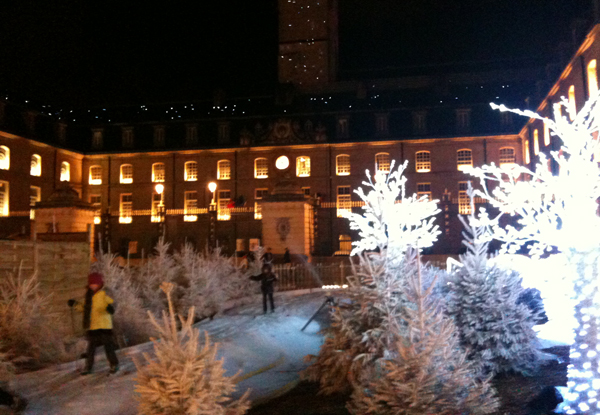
[[446, 205, 538, 375]]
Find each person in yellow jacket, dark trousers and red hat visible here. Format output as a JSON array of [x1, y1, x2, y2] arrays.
[[68, 272, 119, 375]]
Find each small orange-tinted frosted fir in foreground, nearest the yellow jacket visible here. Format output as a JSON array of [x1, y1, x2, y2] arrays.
[[135, 283, 250, 415]]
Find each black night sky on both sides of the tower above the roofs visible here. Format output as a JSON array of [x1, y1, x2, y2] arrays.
[[0, 0, 592, 106]]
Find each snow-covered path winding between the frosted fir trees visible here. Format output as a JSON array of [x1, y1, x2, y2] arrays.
[[13, 291, 326, 415]]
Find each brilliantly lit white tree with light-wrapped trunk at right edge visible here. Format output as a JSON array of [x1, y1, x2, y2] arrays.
[[471, 97, 600, 414]]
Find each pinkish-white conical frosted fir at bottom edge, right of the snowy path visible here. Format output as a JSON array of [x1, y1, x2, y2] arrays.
[[348, 255, 498, 415]]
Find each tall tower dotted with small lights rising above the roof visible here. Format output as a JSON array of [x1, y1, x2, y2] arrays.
[[277, 0, 338, 89]]
